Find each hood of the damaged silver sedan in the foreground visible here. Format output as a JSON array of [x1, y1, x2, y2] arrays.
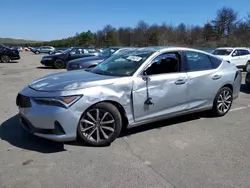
[[29, 70, 118, 92]]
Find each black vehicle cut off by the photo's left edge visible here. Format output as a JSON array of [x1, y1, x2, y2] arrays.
[[0, 44, 20, 63]]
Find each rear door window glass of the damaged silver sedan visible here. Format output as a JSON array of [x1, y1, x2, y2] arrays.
[[186, 51, 213, 72]]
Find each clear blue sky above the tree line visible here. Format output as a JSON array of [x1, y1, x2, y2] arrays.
[[0, 0, 250, 40]]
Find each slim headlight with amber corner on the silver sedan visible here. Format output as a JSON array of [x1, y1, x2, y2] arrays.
[[33, 95, 82, 108]]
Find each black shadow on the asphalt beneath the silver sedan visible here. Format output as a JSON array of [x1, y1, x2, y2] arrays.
[[0, 112, 214, 150]]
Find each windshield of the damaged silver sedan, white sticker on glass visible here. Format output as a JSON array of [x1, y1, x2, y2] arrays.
[[90, 50, 154, 76]]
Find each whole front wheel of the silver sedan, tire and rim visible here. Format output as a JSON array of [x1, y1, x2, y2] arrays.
[[77, 102, 122, 147]]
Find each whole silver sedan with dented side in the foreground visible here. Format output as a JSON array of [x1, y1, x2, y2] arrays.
[[16, 47, 242, 146]]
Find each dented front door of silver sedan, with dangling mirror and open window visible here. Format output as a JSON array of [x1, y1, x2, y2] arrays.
[[132, 52, 188, 122]]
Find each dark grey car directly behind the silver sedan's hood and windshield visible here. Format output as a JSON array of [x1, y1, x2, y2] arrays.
[[66, 47, 137, 71]]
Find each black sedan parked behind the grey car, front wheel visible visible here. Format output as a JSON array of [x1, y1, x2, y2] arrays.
[[41, 47, 99, 69]]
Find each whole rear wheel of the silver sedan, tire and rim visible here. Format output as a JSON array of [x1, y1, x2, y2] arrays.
[[212, 87, 233, 117]]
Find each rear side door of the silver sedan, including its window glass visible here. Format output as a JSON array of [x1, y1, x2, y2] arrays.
[[185, 50, 223, 109]]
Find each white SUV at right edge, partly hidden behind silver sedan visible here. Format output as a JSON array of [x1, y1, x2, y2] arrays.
[[212, 47, 250, 70]]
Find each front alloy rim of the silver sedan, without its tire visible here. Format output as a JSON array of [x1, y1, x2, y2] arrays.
[[79, 108, 115, 143]]
